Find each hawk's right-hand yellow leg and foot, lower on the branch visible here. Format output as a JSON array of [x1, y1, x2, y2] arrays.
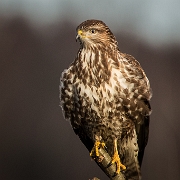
[[111, 139, 126, 174]]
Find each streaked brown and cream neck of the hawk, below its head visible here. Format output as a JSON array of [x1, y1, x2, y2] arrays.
[[76, 44, 118, 83]]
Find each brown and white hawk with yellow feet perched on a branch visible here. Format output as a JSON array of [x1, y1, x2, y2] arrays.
[[59, 19, 152, 180]]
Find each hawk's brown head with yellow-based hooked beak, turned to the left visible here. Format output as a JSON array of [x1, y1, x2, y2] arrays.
[[76, 20, 117, 48]]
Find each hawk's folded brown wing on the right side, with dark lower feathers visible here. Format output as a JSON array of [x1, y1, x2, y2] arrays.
[[121, 54, 152, 165]]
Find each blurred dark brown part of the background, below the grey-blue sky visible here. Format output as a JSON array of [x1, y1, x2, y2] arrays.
[[0, 13, 180, 180]]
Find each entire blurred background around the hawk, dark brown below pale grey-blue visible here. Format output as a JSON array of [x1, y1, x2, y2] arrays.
[[0, 0, 180, 180]]
